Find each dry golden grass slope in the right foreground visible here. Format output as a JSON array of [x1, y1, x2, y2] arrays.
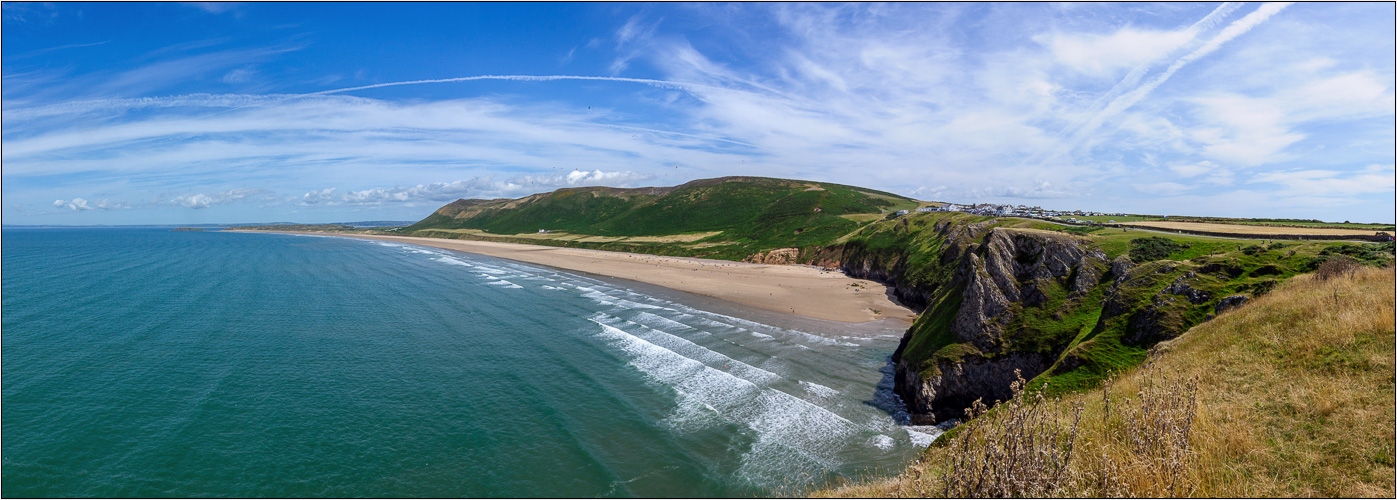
[[813, 267, 1397, 497]]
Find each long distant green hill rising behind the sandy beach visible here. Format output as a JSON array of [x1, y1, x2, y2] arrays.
[[398, 177, 916, 260]]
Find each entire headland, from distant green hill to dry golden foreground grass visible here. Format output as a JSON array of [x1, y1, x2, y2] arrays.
[[243, 177, 1394, 496]]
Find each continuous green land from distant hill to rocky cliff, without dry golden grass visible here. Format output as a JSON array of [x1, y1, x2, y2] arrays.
[[391, 177, 1394, 455]]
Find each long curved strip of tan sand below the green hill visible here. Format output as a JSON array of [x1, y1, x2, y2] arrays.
[[283, 235, 915, 324]]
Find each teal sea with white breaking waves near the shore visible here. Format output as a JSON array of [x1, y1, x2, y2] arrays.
[[0, 228, 932, 497]]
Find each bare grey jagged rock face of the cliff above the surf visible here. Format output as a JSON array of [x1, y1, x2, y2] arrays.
[[894, 225, 1109, 422]]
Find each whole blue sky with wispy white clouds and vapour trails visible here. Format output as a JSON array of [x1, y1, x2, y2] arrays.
[[0, 3, 1397, 225]]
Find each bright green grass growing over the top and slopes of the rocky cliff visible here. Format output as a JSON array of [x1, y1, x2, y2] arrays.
[[845, 214, 1390, 394]]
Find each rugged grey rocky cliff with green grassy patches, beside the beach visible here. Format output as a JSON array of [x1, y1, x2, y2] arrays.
[[802, 215, 1295, 423]]
